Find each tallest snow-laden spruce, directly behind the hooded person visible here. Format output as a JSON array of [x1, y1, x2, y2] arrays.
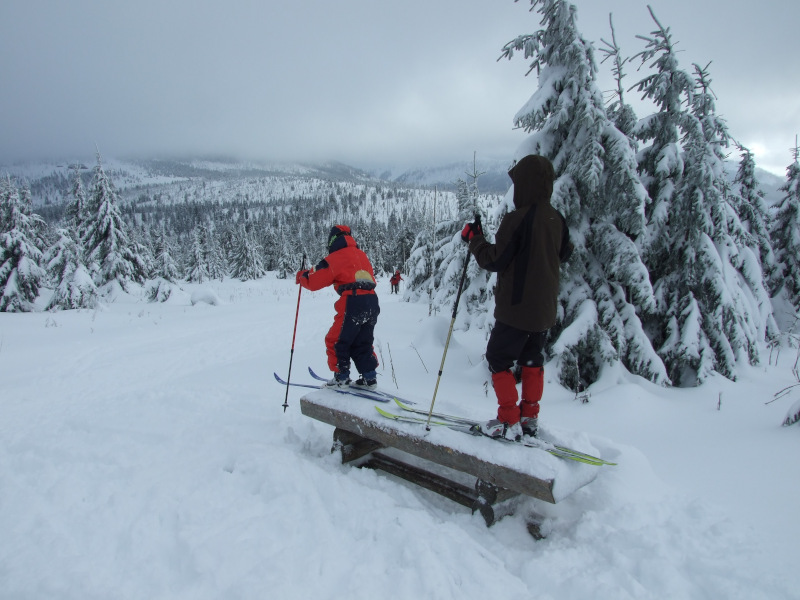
[[502, 0, 668, 389]]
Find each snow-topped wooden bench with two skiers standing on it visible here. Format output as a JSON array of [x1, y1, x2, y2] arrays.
[[300, 390, 597, 525]]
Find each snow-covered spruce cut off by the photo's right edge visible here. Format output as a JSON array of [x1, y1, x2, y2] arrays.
[[772, 138, 800, 313]]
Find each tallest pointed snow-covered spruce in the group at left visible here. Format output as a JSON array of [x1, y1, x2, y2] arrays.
[[81, 152, 147, 289]]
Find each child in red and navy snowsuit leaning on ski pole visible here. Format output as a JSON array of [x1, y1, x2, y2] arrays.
[[295, 225, 381, 389]]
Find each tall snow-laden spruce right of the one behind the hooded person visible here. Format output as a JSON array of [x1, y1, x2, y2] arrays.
[[636, 16, 770, 386]]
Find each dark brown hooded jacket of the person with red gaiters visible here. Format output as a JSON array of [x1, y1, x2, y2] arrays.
[[469, 155, 572, 332]]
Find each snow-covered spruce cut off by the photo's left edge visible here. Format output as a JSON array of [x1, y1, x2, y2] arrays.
[[0, 176, 47, 312]]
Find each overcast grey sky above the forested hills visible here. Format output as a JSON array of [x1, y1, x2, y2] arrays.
[[0, 0, 800, 175]]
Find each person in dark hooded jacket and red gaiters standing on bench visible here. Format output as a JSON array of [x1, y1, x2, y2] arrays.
[[461, 155, 573, 439]]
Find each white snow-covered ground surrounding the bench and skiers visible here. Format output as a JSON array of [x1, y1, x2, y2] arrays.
[[0, 275, 800, 600]]
